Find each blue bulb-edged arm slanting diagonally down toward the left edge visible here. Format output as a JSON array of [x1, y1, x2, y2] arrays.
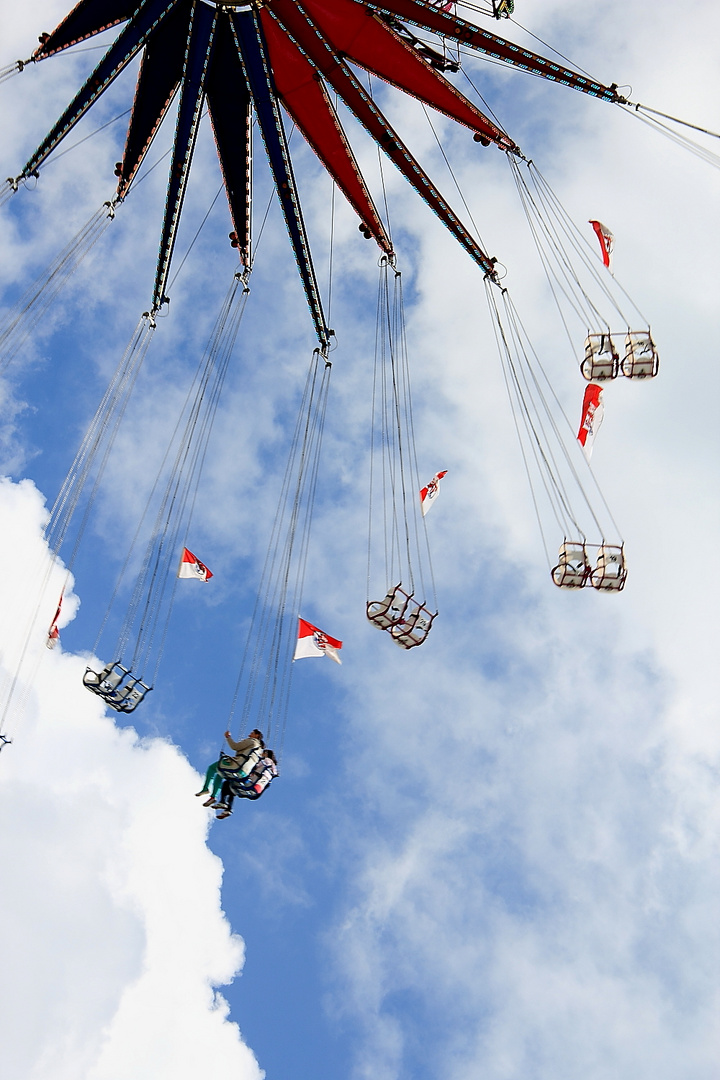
[[21, 0, 185, 177]]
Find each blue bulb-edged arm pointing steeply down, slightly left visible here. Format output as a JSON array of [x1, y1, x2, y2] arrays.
[[152, 2, 217, 311]]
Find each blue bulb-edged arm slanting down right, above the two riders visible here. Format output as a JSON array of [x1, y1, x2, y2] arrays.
[[231, 10, 330, 349]]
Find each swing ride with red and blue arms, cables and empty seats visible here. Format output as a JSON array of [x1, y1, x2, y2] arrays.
[[0, 0, 716, 768]]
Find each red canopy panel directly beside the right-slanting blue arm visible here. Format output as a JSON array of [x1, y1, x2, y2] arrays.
[[260, 8, 393, 254]]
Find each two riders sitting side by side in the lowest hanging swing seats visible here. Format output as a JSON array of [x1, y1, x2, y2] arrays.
[[195, 728, 277, 819]]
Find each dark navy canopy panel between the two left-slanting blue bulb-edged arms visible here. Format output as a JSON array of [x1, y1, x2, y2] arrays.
[[118, 0, 192, 199]]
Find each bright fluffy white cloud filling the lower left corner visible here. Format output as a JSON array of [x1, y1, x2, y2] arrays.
[[0, 480, 262, 1080]]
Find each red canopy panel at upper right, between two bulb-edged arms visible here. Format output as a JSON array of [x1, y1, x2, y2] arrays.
[[301, 0, 515, 150]]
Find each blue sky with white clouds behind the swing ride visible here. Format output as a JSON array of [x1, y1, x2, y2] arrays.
[[0, 0, 720, 1080]]
